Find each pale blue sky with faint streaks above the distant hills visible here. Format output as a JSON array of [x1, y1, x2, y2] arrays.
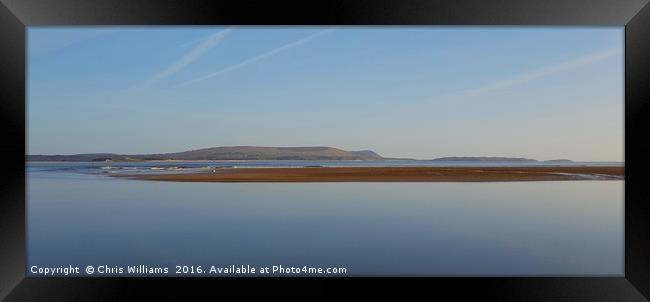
[[27, 26, 624, 161]]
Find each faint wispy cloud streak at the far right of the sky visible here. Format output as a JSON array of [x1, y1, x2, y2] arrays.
[[447, 47, 622, 98]]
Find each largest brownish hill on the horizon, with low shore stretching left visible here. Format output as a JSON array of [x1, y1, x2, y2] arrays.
[[27, 146, 383, 161]]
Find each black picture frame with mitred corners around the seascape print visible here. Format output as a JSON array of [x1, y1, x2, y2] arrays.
[[0, 0, 650, 301]]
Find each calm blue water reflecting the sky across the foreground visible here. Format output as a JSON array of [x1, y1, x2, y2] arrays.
[[27, 162, 624, 276]]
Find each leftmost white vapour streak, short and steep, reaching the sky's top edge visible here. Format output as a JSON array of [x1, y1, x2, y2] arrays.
[[145, 27, 234, 85]]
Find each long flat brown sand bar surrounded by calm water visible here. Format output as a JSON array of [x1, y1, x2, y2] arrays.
[[116, 167, 624, 182]]
